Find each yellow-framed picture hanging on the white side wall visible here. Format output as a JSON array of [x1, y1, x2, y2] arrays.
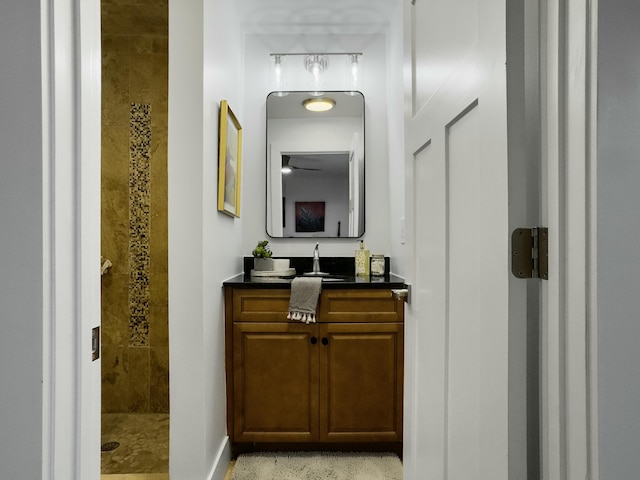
[[218, 100, 242, 217]]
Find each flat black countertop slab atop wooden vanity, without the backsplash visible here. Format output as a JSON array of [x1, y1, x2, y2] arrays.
[[222, 273, 406, 290]]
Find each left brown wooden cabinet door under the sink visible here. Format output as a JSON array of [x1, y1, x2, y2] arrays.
[[233, 323, 319, 442]]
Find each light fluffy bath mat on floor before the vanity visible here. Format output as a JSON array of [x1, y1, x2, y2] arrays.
[[231, 452, 402, 480]]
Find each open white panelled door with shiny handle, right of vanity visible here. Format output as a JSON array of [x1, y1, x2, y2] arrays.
[[405, 0, 526, 480]]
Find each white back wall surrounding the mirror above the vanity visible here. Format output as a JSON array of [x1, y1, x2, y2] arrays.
[[241, 33, 403, 269]]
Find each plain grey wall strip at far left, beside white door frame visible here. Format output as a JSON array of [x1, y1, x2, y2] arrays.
[[0, 0, 44, 479]]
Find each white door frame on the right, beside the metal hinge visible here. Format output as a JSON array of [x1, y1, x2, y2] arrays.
[[540, 0, 598, 480]]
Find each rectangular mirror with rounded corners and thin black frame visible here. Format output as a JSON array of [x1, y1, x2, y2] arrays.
[[266, 91, 365, 238]]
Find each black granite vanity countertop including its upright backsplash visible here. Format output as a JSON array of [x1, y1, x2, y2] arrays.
[[223, 257, 406, 289]]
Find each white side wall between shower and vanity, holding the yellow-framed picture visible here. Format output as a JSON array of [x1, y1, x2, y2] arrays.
[[169, 0, 244, 480]]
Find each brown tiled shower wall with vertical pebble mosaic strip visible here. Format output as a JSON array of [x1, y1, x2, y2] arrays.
[[101, 0, 169, 413]]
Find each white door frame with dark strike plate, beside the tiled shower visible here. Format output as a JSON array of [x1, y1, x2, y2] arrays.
[[41, 0, 101, 480]]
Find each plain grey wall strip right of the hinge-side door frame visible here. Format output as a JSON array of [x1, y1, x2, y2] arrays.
[[597, 0, 640, 480]]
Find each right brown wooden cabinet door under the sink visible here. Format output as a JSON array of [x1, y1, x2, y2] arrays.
[[320, 323, 403, 442]]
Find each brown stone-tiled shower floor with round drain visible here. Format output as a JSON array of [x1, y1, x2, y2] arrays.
[[101, 413, 169, 478]]
